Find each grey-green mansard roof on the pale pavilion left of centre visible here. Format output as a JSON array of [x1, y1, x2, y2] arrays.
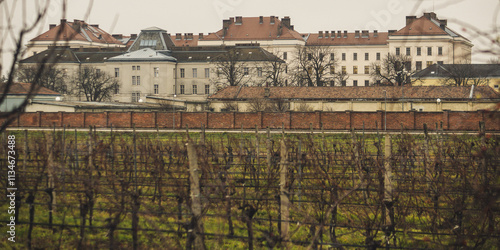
[[128, 27, 174, 52]]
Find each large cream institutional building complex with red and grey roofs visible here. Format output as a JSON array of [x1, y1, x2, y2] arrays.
[[20, 13, 473, 106]]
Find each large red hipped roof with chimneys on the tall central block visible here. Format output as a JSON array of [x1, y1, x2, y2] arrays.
[[204, 16, 304, 41]]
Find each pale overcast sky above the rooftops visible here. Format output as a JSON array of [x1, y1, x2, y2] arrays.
[[0, 0, 500, 74]]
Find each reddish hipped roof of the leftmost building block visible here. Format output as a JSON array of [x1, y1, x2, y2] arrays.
[[30, 19, 123, 45]]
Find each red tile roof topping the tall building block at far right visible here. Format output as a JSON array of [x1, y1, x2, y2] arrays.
[[392, 16, 448, 36]]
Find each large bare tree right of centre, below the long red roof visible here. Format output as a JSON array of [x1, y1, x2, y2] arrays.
[[293, 46, 337, 87]]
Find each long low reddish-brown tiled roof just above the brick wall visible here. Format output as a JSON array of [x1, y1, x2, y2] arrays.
[[209, 86, 500, 100]]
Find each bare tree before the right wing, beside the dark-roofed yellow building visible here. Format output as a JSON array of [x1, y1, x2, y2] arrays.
[[370, 54, 415, 86]]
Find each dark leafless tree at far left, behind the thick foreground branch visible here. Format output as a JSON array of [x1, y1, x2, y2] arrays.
[[16, 65, 68, 94]]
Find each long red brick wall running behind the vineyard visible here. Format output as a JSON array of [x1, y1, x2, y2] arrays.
[[3, 111, 500, 131]]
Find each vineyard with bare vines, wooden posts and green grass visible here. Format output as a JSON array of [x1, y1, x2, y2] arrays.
[[0, 125, 500, 249]]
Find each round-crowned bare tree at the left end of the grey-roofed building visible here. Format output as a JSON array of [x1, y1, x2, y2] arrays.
[[73, 67, 119, 102]]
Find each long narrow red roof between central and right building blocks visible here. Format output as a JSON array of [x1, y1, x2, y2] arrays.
[[306, 32, 389, 46]]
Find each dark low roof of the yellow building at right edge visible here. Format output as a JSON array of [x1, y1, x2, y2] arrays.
[[413, 64, 500, 78]]
